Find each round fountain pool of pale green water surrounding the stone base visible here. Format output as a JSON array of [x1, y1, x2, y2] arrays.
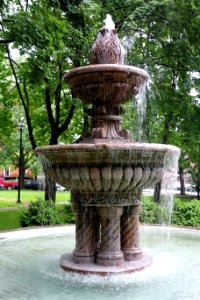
[[0, 226, 200, 300]]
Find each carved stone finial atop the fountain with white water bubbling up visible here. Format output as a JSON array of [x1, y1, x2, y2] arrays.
[[91, 14, 125, 65]]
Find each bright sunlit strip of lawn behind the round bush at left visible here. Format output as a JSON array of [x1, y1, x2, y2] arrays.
[[0, 190, 70, 208]]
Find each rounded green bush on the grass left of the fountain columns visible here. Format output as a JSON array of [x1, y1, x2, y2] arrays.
[[20, 199, 60, 227]]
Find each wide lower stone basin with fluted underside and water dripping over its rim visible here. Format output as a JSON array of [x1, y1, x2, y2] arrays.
[[36, 142, 179, 197]]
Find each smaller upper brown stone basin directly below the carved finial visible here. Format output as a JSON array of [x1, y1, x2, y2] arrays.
[[64, 64, 149, 105]]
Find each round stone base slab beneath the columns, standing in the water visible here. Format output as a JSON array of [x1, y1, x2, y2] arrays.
[[60, 253, 152, 276]]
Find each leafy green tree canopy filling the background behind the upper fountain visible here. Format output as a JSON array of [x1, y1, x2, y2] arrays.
[[0, 0, 200, 199]]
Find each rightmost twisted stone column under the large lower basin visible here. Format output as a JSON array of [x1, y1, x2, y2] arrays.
[[121, 198, 142, 261]]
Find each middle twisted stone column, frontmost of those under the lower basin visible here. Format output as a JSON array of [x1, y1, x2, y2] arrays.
[[97, 207, 124, 266]]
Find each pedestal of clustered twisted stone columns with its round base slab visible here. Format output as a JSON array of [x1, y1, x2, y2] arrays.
[[60, 193, 152, 275]]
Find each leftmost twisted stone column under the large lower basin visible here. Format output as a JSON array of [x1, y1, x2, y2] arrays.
[[73, 204, 95, 263]]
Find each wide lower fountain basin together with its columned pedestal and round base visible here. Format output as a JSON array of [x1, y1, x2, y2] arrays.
[[36, 143, 179, 275]]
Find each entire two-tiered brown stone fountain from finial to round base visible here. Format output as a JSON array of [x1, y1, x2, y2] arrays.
[[36, 15, 179, 275]]
